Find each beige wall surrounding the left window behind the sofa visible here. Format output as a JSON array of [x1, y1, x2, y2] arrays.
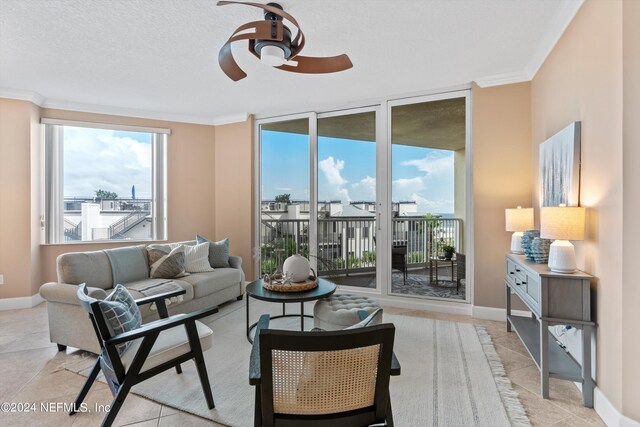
[[0, 103, 230, 298]]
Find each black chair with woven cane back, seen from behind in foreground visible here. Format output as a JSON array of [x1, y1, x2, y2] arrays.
[[249, 311, 400, 427]]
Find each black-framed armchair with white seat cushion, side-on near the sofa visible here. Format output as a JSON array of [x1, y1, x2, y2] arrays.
[[69, 284, 218, 427]]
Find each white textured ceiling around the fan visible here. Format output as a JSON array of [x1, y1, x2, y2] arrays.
[[0, 0, 581, 122]]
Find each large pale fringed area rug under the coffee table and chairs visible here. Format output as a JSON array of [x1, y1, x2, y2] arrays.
[[65, 301, 530, 427]]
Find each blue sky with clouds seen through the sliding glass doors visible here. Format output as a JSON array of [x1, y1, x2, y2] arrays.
[[262, 131, 454, 213]]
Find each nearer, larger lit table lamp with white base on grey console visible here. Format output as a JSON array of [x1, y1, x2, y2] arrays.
[[540, 205, 585, 273]]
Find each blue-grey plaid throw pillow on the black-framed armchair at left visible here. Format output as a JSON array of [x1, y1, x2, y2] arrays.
[[98, 285, 142, 354]]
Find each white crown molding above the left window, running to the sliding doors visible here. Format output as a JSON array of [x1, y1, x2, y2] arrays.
[[0, 88, 249, 126]]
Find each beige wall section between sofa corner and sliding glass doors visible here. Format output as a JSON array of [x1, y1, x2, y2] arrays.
[[213, 117, 254, 280]]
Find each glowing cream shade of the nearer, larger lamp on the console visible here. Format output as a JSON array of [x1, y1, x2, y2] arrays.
[[540, 206, 585, 240]]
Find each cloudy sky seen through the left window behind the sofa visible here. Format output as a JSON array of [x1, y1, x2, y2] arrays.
[[64, 126, 152, 198]]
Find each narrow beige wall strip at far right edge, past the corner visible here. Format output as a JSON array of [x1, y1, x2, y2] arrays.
[[621, 0, 640, 420]]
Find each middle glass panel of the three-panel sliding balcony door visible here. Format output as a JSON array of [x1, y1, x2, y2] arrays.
[[317, 108, 378, 288]]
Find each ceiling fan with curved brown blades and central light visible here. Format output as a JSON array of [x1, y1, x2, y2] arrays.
[[218, 1, 353, 81]]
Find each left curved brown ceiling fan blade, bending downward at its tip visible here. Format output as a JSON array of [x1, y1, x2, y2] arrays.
[[218, 21, 283, 82]]
